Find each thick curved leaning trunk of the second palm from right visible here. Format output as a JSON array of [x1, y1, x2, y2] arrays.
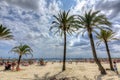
[[88, 32, 106, 74]]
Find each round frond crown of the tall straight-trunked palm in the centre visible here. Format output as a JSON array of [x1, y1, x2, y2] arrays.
[[50, 11, 78, 35]]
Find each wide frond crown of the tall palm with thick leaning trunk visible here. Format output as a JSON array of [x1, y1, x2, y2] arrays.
[[78, 10, 111, 32]]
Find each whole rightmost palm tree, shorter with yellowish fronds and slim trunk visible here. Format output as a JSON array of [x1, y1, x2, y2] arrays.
[[96, 29, 118, 70]]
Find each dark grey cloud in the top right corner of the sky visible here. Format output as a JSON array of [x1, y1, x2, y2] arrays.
[[95, 0, 120, 18]]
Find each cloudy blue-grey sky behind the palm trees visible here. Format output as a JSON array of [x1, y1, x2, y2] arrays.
[[0, 0, 120, 58]]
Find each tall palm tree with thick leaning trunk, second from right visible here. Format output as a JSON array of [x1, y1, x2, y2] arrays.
[[78, 10, 111, 74]]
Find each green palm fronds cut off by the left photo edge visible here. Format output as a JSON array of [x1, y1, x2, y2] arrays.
[[0, 25, 13, 40]]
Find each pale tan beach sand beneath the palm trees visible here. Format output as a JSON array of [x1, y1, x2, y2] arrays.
[[0, 62, 120, 80]]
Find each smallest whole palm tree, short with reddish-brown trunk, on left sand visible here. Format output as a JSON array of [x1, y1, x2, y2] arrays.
[[11, 44, 33, 71]]
